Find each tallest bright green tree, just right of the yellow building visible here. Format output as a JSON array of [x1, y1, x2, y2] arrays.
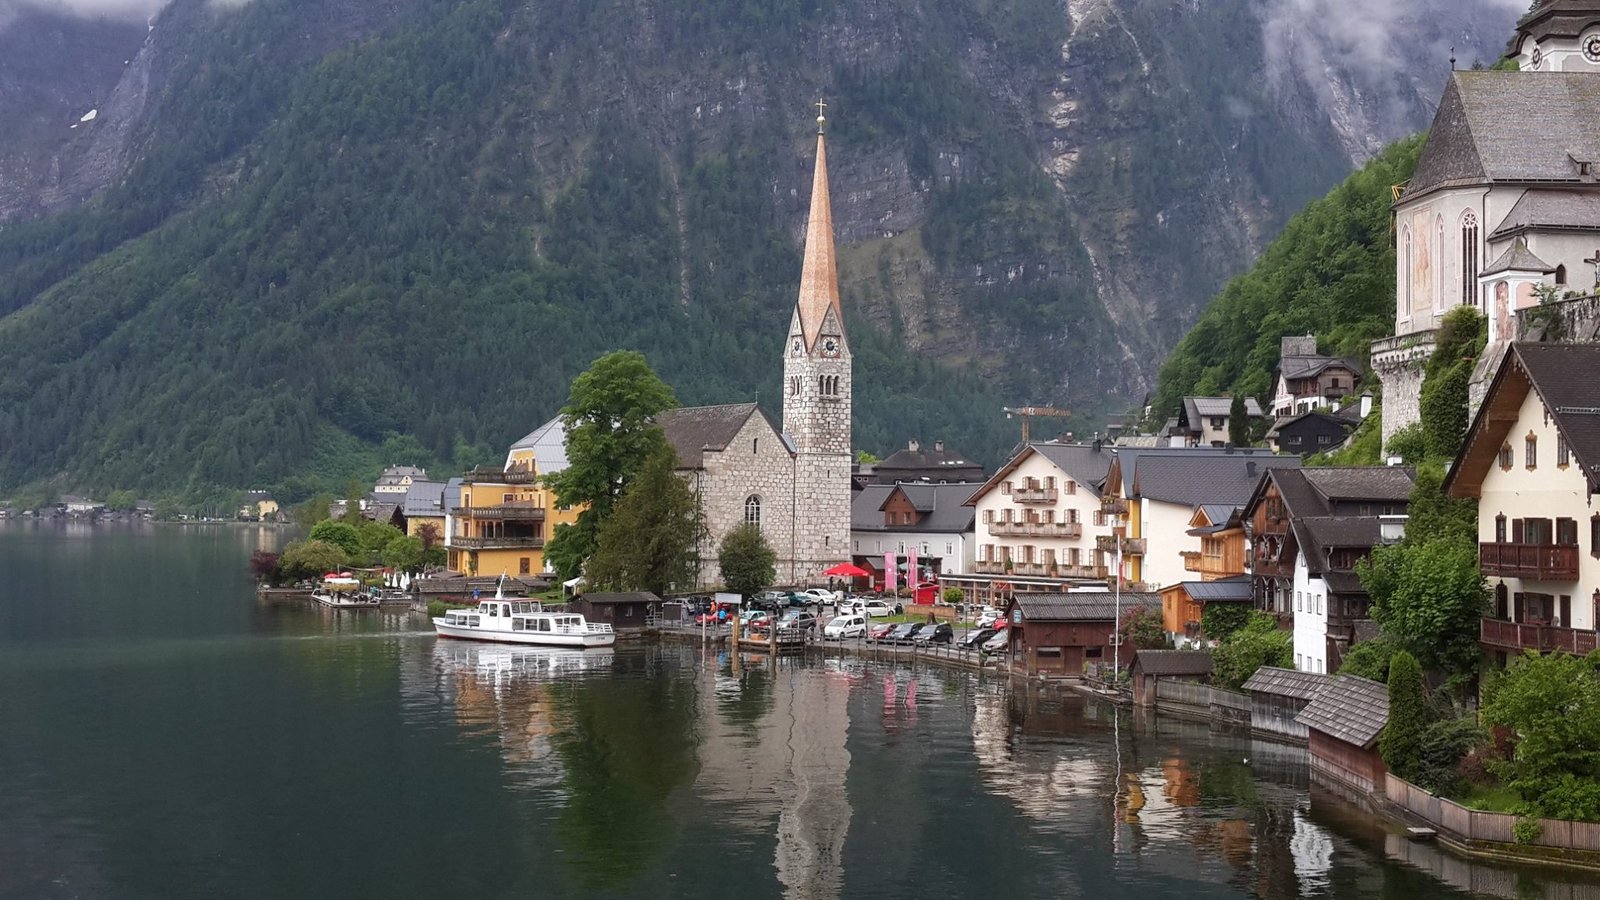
[[546, 351, 678, 578]]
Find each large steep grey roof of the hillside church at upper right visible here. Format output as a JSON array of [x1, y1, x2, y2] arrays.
[[1400, 70, 1600, 202]]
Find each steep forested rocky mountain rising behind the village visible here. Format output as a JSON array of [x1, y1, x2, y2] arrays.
[[0, 0, 1518, 496]]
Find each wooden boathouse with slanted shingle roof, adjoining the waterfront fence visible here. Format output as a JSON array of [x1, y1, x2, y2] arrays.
[[1296, 676, 1389, 794]]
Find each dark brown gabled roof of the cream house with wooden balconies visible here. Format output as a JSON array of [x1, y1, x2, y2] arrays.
[[1445, 341, 1600, 496]]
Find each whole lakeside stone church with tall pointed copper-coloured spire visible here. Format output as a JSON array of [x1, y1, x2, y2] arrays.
[[656, 108, 853, 586]]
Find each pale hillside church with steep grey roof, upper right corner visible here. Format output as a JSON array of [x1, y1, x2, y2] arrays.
[[1373, 0, 1600, 445]]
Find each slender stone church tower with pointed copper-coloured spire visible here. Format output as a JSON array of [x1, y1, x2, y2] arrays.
[[784, 115, 851, 566]]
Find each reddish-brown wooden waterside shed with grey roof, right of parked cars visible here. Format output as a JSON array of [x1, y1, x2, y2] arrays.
[[1006, 591, 1162, 674]]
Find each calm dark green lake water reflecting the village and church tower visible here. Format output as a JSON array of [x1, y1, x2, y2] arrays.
[[0, 524, 1584, 900]]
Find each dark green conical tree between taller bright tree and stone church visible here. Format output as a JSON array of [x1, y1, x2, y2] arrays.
[[586, 445, 704, 594]]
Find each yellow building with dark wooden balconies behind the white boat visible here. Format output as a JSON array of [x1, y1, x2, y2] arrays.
[[445, 447, 581, 575]]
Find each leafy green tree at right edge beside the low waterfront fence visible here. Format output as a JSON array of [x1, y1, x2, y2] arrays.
[[1483, 650, 1600, 822]]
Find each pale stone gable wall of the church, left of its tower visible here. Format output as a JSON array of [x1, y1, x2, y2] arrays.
[[691, 413, 806, 585]]
